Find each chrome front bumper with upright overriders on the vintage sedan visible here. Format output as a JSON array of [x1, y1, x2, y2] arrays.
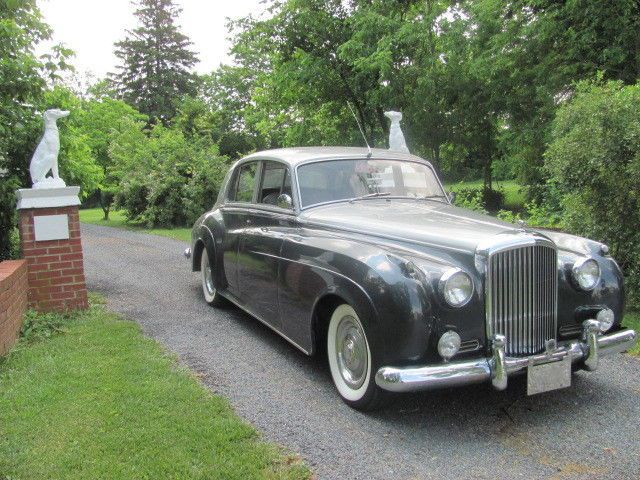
[[376, 320, 636, 392]]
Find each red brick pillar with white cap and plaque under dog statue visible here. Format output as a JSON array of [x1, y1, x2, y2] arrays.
[[16, 187, 88, 312]]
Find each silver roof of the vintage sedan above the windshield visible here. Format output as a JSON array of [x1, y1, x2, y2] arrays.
[[241, 147, 436, 166]]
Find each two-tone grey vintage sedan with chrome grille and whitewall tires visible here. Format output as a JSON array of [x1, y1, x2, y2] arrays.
[[185, 147, 636, 409]]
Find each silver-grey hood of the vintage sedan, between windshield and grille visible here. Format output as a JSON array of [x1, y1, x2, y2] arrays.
[[301, 199, 536, 253]]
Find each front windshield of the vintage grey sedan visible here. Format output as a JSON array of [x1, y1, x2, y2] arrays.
[[298, 159, 444, 207]]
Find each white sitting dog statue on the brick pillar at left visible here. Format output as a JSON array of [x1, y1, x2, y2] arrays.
[[29, 108, 69, 188]]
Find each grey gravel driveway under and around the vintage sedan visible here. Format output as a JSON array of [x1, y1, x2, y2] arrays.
[[82, 225, 640, 480]]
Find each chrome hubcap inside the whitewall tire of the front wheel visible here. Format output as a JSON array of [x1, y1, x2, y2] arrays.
[[336, 316, 368, 389]]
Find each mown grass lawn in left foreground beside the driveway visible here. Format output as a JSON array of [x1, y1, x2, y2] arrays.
[[0, 300, 310, 479]]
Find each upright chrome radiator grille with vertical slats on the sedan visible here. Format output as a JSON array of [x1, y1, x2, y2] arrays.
[[486, 245, 558, 356]]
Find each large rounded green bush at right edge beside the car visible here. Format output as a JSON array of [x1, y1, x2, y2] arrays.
[[545, 82, 640, 306]]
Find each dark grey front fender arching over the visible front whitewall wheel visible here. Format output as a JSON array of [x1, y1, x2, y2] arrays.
[[280, 229, 444, 363]]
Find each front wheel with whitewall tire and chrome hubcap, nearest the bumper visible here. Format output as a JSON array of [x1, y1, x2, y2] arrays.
[[327, 304, 386, 410]]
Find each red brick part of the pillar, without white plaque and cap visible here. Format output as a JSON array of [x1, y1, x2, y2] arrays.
[[19, 206, 88, 311]]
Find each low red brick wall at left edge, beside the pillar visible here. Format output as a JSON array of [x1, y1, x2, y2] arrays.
[[0, 260, 27, 356]]
